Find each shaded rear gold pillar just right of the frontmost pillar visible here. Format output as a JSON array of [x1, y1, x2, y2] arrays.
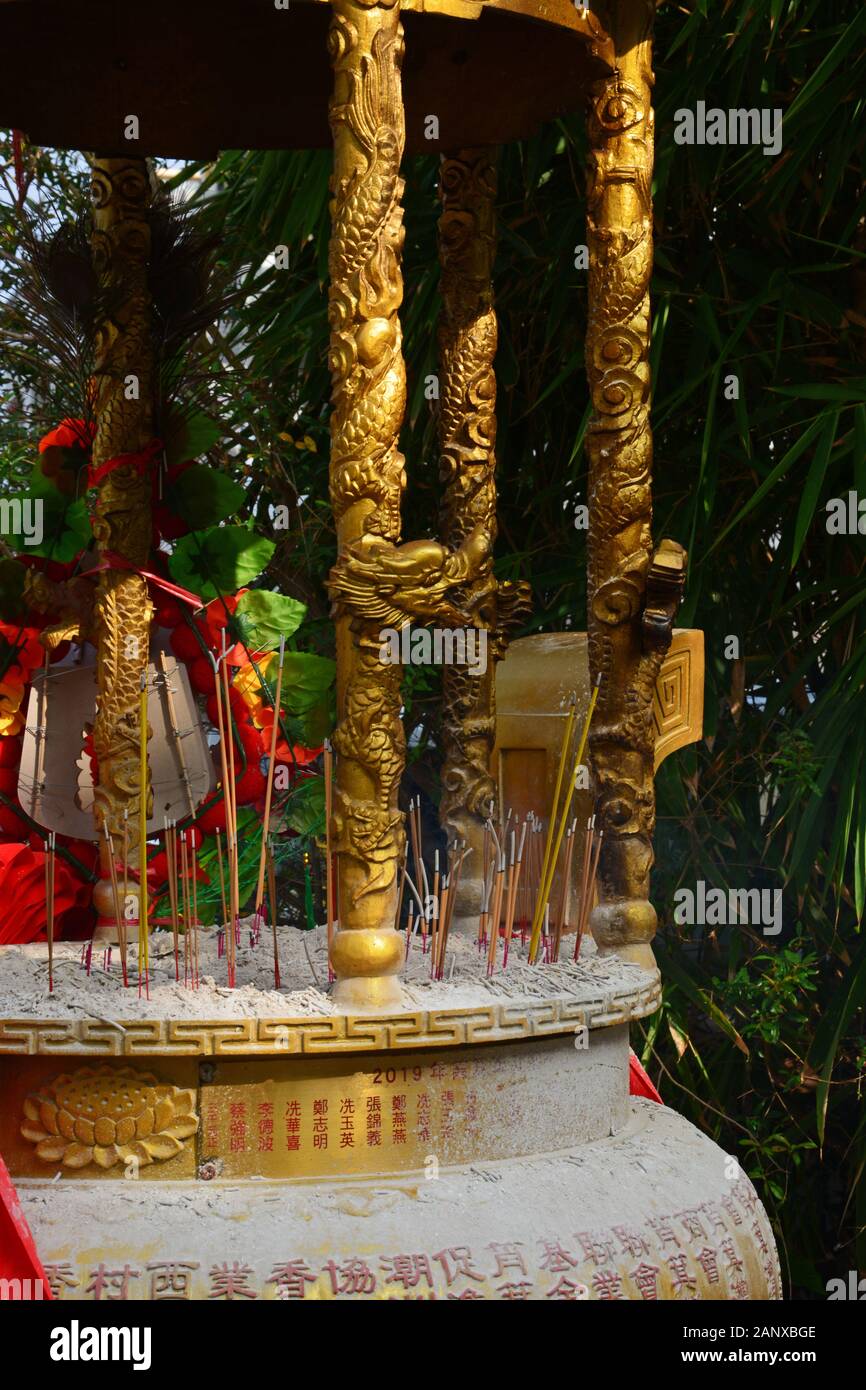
[[439, 149, 530, 923]]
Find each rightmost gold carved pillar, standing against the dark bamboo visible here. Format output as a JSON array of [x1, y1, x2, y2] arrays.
[[587, 0, 685, 966]]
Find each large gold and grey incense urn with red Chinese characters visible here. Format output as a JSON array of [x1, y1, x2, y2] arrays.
[[0, 966, 781, 1301]]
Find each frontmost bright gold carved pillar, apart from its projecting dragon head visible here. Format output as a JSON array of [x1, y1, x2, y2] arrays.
[[328, 0, 406, 1006]]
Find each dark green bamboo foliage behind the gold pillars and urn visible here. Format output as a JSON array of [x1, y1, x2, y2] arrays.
[[3, 0, 866, 1297]]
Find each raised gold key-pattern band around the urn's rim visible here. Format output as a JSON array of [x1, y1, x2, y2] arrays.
[[0, 973, 662, 1058]]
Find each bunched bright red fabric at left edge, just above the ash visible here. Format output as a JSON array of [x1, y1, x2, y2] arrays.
[[0, 844, 90, 945]]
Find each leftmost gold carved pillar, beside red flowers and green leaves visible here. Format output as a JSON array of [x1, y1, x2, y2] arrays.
[[92, 158, 154, 917]]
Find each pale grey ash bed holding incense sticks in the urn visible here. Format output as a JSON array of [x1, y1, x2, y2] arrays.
[[0, 919, 653, 1022]]
